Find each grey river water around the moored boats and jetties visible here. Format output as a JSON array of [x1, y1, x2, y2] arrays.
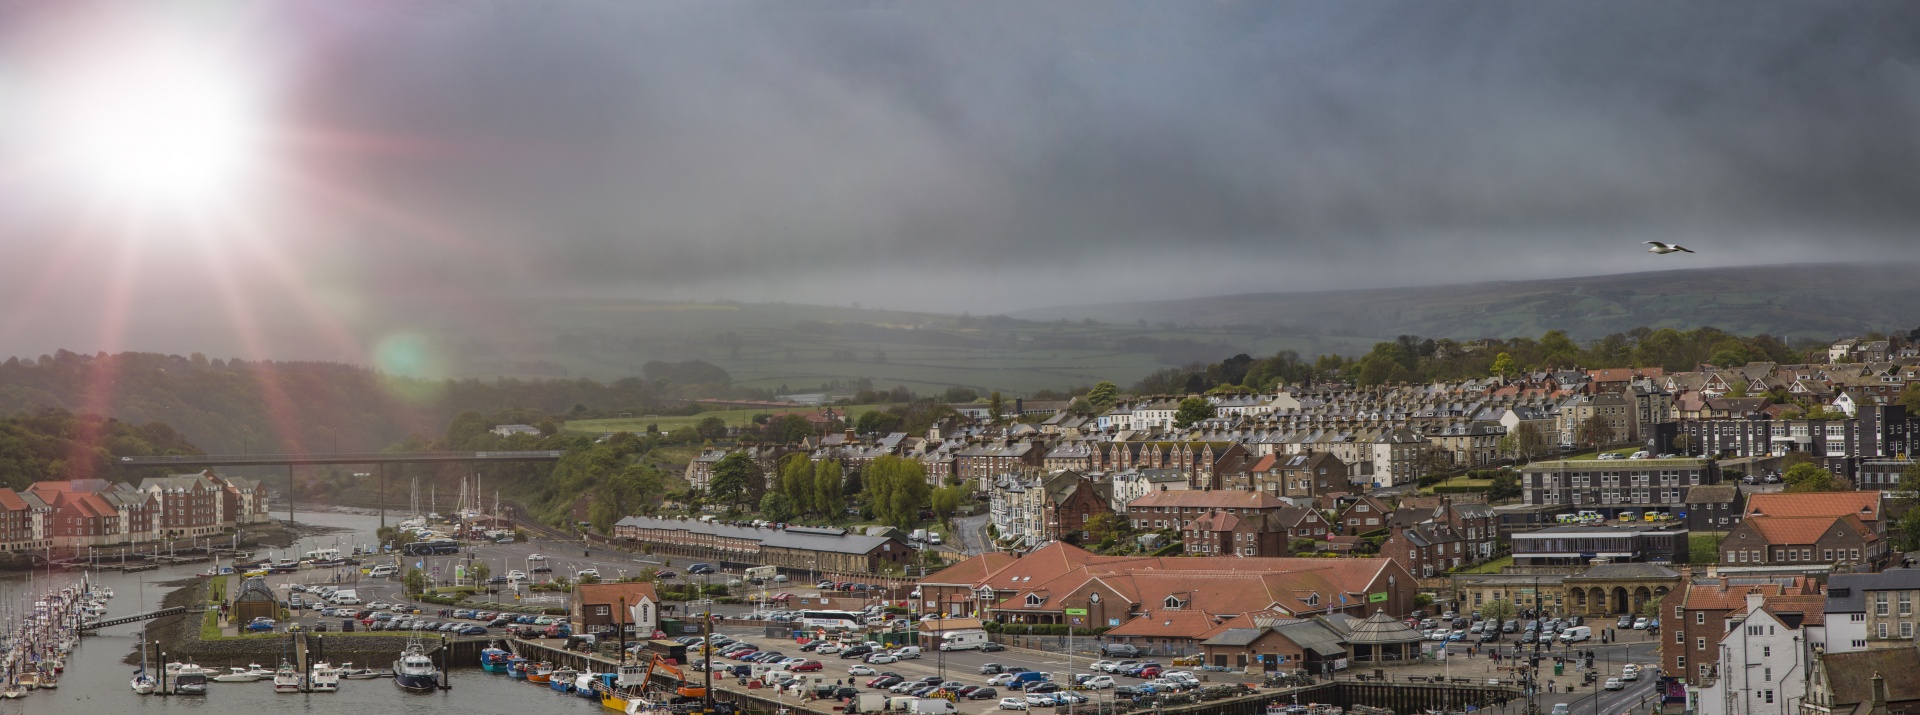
[[0, 513, 601, 715]]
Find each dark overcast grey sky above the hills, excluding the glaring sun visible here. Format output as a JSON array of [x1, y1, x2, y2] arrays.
[[0, 0, 1920, 352]]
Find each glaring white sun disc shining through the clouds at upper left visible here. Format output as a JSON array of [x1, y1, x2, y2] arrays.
[[42, 41, 263, 211]]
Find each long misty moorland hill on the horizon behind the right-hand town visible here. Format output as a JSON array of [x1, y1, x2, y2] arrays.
[[1014, 263, 1920, 340]]
